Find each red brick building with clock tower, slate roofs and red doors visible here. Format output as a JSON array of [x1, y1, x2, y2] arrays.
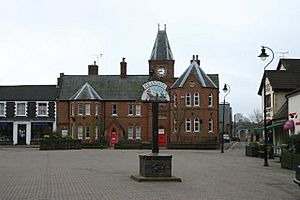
[[57, 26, 219, 146]]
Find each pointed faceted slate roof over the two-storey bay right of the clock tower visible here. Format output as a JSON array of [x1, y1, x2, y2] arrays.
[[171, 60, 218, 89]]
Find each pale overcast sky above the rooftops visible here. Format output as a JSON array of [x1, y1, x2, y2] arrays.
[[0, 0, 300, 116]]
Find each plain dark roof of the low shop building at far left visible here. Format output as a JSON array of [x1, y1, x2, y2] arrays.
[[0, 85, 58, 101]]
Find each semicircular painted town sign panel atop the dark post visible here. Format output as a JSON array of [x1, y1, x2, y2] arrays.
[[141, 81, 170, 102]]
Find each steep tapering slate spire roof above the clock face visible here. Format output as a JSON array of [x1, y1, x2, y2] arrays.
[[150, 30, 174, 60]]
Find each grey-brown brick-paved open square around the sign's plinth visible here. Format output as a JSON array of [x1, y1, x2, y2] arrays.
[[0, 145, 300, 200]]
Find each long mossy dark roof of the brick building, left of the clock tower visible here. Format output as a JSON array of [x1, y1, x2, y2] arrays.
[[59, 75, 149, 100]]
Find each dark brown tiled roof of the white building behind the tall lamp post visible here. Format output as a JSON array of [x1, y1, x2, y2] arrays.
[[258, 68, 300, 95]]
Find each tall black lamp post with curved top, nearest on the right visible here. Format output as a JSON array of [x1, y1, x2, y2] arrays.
[[258, 46, 274, 167]]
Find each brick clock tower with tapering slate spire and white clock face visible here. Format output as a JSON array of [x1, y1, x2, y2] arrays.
[[149, 25, 175, 87]]
